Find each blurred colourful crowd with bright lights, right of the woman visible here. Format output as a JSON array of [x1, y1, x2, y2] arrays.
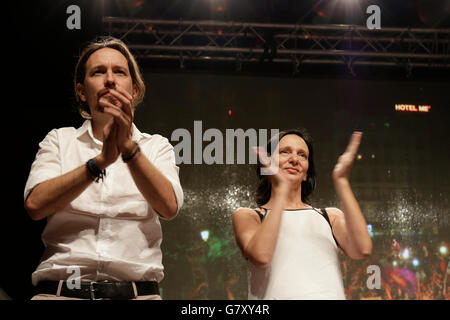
[[341, 239, 450, 300]]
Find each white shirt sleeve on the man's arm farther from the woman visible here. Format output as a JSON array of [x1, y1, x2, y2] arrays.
[[24, 129, 61, 201]]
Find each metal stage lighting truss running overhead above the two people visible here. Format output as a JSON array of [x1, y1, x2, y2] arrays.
[[103, 17, 450, 73]]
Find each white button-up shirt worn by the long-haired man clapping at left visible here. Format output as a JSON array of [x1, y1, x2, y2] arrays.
[[24, 120, 183, 285]]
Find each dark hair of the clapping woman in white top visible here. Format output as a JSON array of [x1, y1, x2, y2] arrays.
[[256, 129, 316, 206]]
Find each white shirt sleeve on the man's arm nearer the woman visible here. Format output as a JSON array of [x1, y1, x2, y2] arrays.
[[153, 137, 184, 219]]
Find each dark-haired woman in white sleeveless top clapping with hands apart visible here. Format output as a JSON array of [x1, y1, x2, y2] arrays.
[[233, 129, 372, 299]]
